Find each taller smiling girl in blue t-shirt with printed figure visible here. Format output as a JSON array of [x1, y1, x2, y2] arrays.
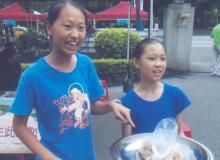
[[10, 0, 133, 160]]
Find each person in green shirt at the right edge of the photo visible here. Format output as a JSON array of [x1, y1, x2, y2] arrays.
[[211, 24, 220, 76]]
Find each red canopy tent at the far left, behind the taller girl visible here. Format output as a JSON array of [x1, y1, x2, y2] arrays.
[[0, 3, 46, 21]]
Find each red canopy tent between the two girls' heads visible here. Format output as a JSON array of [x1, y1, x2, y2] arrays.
[[95, 1, 149, 21]]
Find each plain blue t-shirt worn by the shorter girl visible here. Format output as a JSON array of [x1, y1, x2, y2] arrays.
[[121, 84, 191, 134]]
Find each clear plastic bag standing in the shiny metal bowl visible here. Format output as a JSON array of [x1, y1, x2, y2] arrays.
[[152, 118, 178, 158]]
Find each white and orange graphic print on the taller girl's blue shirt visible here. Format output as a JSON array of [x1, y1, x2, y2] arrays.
[[54, 83, 90, 134]]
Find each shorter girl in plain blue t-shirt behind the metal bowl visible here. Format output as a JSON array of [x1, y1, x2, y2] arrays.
[[121, 39, 190, 136]]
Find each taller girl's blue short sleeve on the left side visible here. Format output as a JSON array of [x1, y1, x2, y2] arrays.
[[10, 70, 34, 116]]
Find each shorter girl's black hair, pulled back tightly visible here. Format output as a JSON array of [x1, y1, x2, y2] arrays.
[[134, 38, 163, 59]]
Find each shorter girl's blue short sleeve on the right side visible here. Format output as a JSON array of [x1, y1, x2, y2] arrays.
[[174, 87, 191, 115]]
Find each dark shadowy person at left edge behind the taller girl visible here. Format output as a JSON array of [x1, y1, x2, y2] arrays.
[[0, 41, 22, 91]]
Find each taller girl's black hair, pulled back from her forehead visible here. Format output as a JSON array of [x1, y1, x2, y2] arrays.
[[47, 0, 88, 25]]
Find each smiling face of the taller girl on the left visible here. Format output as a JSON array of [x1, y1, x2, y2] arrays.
[[47, 5, 86, 55]]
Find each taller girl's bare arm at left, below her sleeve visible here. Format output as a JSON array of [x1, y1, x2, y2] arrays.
[[13, 115, 60, 160]]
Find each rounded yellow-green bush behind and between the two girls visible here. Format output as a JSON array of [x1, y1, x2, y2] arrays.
[[94, 28, 141, 58]]
